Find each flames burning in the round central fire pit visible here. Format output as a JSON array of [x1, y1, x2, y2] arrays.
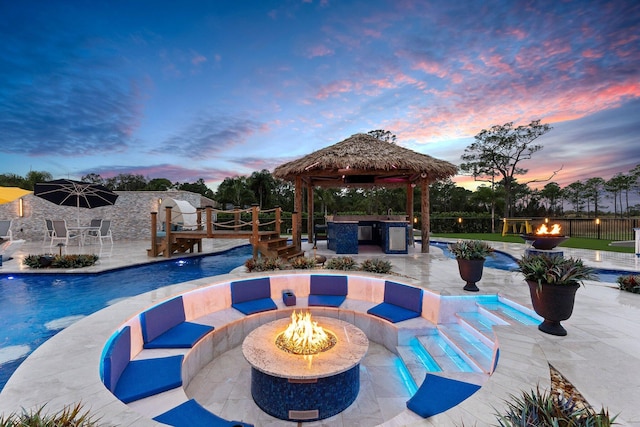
[[276, 311, 337, 355]]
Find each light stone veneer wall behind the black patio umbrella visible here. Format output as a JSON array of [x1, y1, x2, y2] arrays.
[[0, 191, 214, 241]]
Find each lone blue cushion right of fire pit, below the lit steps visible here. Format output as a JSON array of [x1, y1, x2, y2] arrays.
[[407, 374, 480, 418]]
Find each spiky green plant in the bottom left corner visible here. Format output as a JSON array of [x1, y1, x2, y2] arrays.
[[0, 403, 100, 427]]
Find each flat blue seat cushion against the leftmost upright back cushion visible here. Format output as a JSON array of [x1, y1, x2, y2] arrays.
[[113, 355, 184, 403]]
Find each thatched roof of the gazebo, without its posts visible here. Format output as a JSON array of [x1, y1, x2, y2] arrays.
[[273, 133, 458, 187]]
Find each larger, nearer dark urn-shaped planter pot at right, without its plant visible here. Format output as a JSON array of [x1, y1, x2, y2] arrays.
[[527, 280, 580, 337]]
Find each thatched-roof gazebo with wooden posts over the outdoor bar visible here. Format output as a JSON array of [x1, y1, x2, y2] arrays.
[[273, 133, 458, 252]]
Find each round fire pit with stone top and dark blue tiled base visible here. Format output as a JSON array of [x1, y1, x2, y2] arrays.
[[242, 317, 369, 421]]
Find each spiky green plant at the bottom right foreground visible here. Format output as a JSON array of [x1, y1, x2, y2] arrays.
[[496, 387, 616, 427]]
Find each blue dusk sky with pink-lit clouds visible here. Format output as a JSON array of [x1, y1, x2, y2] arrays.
[[0, 0, 640, 189]]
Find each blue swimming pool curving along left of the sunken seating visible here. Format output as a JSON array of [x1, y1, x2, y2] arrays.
[[0, 245, 252, 390]]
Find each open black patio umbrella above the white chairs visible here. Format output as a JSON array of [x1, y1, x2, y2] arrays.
[[33, 179, 118, 225]]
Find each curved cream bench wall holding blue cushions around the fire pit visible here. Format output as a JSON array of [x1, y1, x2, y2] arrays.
[[101, 273, 500, 424]]
